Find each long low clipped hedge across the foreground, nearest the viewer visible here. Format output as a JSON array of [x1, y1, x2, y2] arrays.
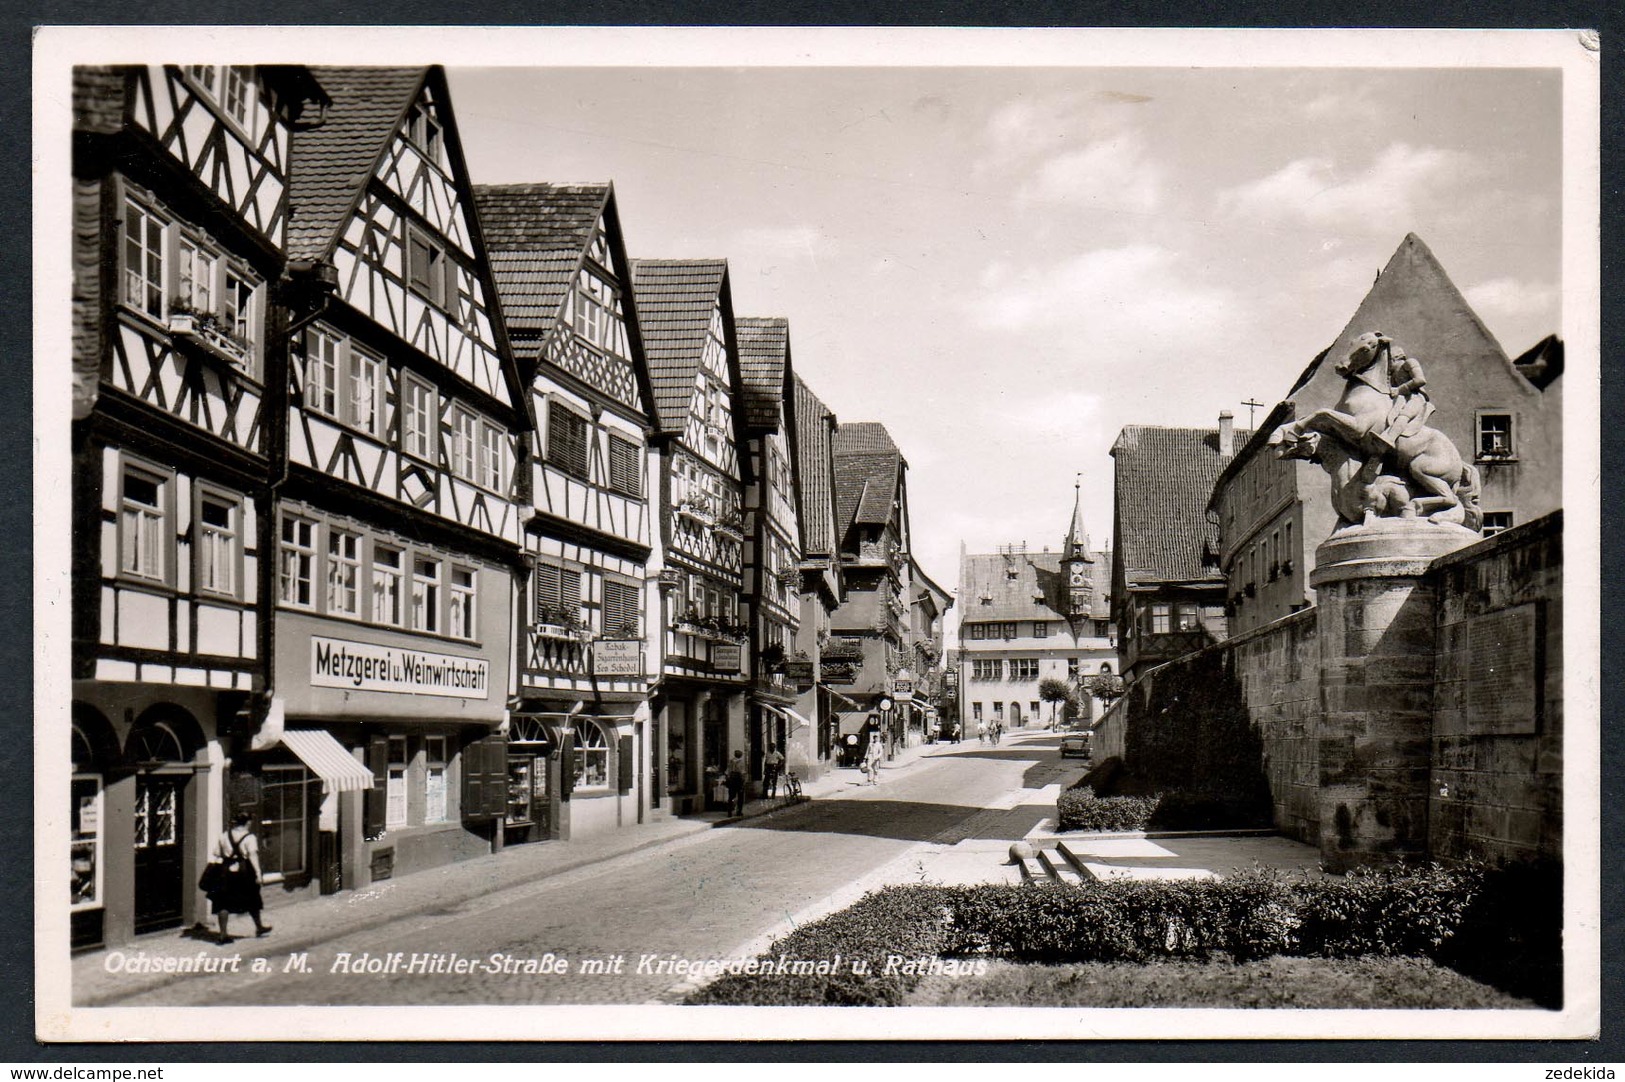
[[687, 866, 1562, 1006]]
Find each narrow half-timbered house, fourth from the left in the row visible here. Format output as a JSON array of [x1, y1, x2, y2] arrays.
[[632, 260, 749, 814]]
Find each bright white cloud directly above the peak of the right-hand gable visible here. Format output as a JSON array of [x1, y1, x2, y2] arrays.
[[1217, 143, 1477, 232]]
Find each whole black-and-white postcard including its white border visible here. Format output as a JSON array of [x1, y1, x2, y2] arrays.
[[34, 28, 1601, 1041]]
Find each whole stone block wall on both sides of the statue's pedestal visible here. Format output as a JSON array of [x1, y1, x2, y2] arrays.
[[1095, 512, 1563, 863]]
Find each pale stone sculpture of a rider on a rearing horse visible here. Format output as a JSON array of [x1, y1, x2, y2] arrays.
[[1269, 331, 1484, 530]]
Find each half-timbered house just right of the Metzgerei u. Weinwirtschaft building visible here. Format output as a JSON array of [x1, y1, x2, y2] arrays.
[[475, 184, 663, 840]]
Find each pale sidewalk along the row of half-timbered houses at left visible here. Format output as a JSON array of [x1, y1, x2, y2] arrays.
[[72, 744, 954, 1006]]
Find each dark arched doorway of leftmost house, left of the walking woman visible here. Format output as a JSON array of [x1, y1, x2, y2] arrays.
[[124, 715, 195, 934]]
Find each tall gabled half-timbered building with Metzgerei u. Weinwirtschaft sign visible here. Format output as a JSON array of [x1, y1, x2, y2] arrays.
[[271, 68, 530, 889]]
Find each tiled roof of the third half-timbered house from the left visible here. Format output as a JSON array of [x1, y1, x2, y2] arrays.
[[475, 184, 609, 338]]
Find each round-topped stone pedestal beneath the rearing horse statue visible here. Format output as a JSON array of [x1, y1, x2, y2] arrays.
[[1310, 518, 1479, 871]]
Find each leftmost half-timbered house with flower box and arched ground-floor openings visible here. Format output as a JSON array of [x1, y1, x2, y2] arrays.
[[72, 65, 325, 946]]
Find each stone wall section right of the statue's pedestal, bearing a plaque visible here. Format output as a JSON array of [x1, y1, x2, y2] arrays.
[[1428, 512, 1563, 863]]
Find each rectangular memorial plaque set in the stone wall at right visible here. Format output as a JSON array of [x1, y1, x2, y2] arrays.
[[1458, 604, 1545, 734]]
